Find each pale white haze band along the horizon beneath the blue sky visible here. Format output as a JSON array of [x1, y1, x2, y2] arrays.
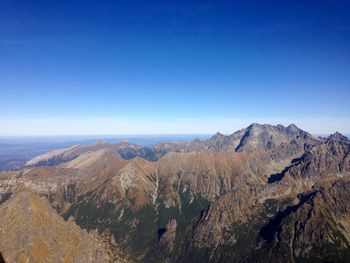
[[0, 117, 350, 136]]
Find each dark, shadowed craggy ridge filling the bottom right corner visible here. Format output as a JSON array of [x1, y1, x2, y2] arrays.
[[259, 178, 350, 262]]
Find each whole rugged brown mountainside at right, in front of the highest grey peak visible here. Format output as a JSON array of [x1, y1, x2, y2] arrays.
[[180, 140, 350, 262]]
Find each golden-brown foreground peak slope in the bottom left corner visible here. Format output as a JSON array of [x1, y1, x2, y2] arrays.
[[0, 192, 127, 262]]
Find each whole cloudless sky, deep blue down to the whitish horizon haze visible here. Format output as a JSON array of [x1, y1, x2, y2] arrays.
[[0, 0, 350, 135]]
